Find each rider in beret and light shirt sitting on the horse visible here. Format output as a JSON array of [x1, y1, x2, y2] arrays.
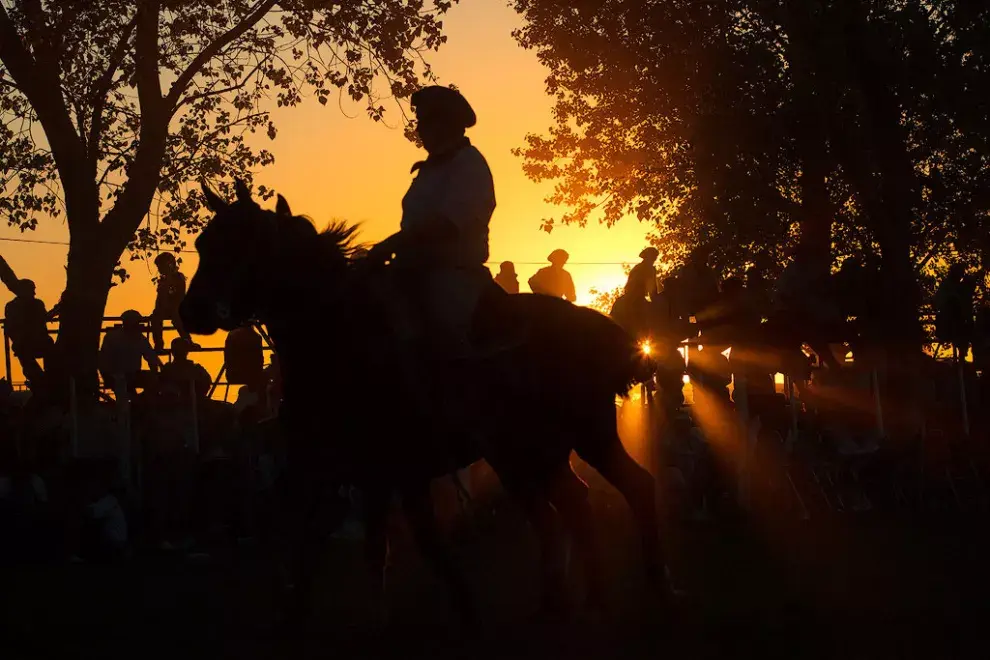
[[369, 86, 495, 356]]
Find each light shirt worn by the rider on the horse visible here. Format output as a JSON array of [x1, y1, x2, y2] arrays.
[[400, 144, 495, 267]]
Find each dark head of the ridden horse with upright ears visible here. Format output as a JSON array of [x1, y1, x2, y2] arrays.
[[180, 181, 296, 335]]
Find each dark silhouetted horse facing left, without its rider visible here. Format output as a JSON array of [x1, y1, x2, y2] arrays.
[[181, 183, 666, 624]]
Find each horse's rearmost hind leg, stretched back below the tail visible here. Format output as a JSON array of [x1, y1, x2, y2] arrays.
[[575, 404, 669, 593]]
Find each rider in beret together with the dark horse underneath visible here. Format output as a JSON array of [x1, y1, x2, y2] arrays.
[[181, 87, 667, 622]]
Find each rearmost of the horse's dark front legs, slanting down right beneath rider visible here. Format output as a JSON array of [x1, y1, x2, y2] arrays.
[[401, 482, 480, 630]]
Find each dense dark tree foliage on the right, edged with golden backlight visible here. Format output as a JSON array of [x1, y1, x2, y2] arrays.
[[515, 0, 990, 292]]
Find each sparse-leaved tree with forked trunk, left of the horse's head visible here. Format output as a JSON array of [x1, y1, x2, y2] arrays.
[[0, 0, 451, 392]]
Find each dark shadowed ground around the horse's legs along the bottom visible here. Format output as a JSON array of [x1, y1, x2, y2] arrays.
[[0, 458, 990, 659]]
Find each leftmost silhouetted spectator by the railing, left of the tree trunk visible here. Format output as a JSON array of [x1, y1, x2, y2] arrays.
[[4, 280, 55, 389]]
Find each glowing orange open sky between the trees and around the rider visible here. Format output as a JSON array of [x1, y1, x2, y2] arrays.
[[0, 0, 648, 382]]
